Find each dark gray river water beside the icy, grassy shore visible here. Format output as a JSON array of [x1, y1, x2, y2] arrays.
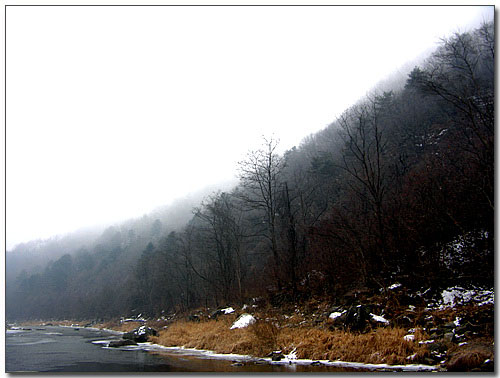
[[5, 326, 359, 373]]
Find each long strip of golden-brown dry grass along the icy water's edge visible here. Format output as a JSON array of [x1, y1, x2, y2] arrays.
[[153, 318, 429, 364]]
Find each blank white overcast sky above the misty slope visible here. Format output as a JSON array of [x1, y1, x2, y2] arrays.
[[6, 6, 493, 250]]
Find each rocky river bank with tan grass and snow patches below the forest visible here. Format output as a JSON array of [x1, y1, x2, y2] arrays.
[[13, 285, 494, 371]]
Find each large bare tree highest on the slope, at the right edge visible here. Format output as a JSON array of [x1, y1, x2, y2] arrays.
[[413, 23, 494, 211]]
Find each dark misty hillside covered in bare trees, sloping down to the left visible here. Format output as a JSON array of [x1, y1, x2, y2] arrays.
[[6, 23, 495, 319]]
